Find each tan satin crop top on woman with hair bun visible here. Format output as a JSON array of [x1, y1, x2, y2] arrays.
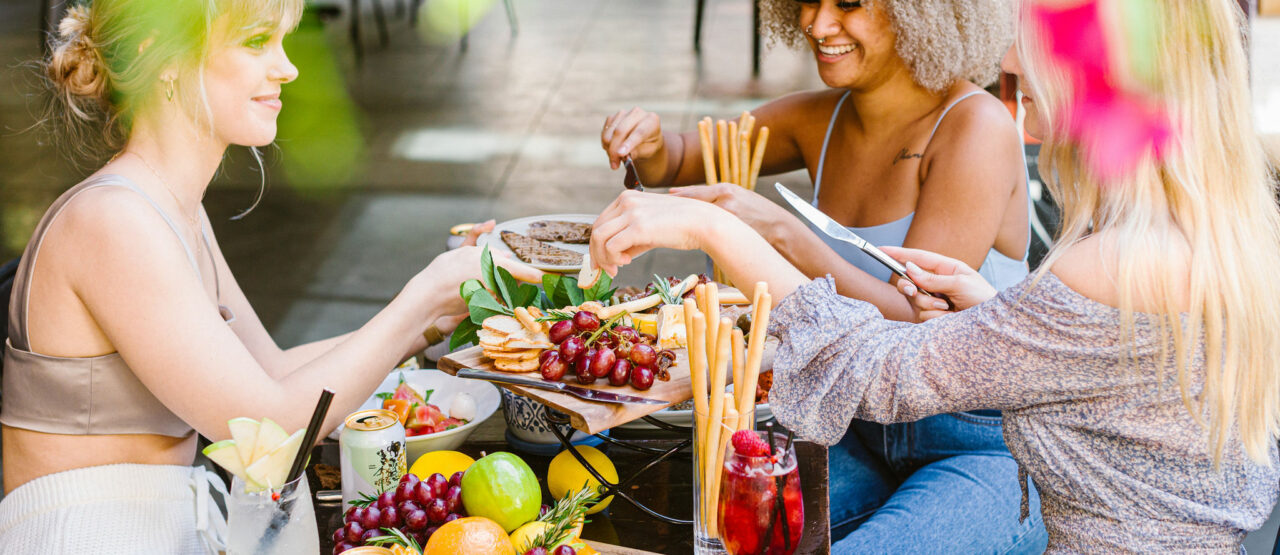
[[0, 175, 229, 437]]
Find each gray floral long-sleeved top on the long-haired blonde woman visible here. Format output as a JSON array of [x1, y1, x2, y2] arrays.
[[769, 274, 1280, 552]]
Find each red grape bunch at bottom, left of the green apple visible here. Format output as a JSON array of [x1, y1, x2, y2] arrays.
[[333, 472, 466, 555]]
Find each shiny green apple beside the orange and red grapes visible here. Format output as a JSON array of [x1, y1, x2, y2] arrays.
[[462, 453, 543, 533]]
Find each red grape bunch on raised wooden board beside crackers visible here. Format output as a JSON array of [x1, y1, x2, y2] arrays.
[[539, 311, 676, 391]]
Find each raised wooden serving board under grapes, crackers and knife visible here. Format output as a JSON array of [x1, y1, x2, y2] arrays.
[[438, 347, 694, 434]]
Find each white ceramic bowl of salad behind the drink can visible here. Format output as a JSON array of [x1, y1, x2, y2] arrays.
[[350, 370, 500, 465]]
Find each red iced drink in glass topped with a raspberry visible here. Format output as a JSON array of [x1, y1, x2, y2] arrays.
[[718, 430, 804, 555]]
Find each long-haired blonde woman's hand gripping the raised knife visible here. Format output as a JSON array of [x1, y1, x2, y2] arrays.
[[881, 247, 996, 322]]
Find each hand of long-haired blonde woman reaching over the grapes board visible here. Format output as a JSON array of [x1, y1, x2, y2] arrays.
[[591, 191, 732, 276]]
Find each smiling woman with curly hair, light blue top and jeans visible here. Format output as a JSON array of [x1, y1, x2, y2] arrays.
[[602, 0, 1046, 552]]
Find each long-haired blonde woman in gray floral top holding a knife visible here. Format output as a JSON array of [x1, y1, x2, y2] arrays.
[[591, 0, 1280, 552]]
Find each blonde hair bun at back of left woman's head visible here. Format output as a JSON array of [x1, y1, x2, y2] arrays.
[[49, 5, 108, 102]]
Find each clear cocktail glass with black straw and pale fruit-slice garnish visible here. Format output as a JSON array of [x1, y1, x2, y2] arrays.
[[227, 474, 320, 555]]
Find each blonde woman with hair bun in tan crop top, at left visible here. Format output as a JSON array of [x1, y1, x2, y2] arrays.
[[0, 0, 539, 552]]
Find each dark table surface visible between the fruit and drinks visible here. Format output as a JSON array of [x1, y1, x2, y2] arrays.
[[307, 414, 831, 555]]
